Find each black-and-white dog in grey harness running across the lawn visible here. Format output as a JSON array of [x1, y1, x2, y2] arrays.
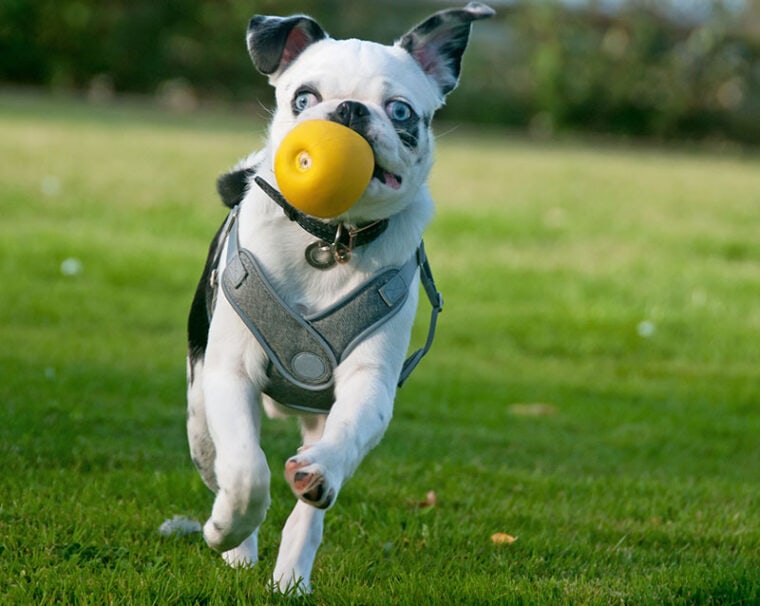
[[187, 2, 494, 593]]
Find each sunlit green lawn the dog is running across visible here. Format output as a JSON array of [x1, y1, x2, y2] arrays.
[[0, 94, 760, 605]]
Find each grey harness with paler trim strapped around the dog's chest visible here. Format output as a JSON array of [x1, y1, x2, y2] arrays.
[[212, 209, 443, 413]]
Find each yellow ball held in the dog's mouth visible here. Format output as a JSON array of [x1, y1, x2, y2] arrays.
[[274, 120, 375, 219]]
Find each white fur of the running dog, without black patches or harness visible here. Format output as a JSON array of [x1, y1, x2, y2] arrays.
[[188, 5, 490, 592]]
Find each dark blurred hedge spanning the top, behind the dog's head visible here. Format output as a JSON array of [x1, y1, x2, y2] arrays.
[[0, 0, 760, 144]]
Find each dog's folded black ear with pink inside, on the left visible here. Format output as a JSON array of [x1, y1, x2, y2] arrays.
[[246, 15, 327, 77]]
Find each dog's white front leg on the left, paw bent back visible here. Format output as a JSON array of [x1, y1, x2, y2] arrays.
[[203, 364, 270, 564]]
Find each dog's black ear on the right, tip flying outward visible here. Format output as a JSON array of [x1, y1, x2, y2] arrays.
[[396, 2, 495, 95]]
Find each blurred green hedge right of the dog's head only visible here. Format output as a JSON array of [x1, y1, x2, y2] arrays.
[[447, 0, 760, 142]]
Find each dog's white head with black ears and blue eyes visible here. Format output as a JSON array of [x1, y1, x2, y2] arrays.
[[247, 2, 494, 220]]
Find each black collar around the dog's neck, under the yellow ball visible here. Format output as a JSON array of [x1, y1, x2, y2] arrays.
[[254, 175, 388, 262]]
